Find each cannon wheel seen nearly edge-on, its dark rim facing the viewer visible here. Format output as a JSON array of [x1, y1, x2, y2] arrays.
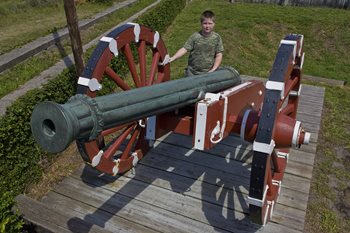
[[248, 34, 303, 225]]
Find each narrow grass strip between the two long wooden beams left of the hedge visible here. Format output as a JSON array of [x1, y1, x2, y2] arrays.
[[0, 0, 155, 98]]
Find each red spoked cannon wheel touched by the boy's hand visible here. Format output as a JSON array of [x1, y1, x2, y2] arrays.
[[76, 23, 170, 175]]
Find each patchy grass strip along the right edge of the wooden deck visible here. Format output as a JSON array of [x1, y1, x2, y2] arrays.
[[305, 83, 350, 232]]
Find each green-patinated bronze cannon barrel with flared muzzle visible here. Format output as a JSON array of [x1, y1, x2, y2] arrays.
[[31, 68, 241, 153]]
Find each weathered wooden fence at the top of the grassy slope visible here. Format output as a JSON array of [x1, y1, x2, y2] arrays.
[[230, 0, 350, 9]]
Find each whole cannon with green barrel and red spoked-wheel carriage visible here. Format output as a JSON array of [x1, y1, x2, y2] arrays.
[[31, 23, 310, 225]]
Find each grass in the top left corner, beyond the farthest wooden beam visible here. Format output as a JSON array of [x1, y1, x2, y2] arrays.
[[0, 0, 123, 55]]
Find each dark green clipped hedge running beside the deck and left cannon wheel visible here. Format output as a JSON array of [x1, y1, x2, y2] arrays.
[[0, 0, 189, 229]]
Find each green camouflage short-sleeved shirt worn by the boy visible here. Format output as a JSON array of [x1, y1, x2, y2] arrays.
[[184, 32, 224, 75]]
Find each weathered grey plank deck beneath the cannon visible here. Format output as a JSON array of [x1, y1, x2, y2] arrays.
[[19, 85, 324, 233]]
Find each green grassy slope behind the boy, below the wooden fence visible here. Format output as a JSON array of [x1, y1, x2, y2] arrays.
[[164, 1, 350, 82]]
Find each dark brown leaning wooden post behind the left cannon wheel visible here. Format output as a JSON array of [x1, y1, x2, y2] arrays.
[[63, 0, 84, 76]]
